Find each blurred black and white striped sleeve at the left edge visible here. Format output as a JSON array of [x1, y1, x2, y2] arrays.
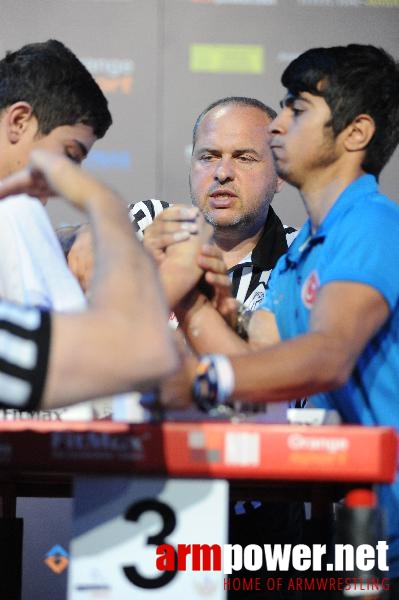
[[0, 301, 50, 410]]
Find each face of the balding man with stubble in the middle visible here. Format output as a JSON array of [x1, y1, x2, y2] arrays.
[[190, 104, 278, 232]]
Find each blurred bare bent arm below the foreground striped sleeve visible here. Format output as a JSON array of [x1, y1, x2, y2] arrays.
[[43, 193, 178, 407]]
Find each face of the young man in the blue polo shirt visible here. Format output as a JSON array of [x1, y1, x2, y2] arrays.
[[269, 92, 339, 189]]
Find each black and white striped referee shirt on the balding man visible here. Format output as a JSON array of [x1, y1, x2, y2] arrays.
[[129, 200, 297, 310]]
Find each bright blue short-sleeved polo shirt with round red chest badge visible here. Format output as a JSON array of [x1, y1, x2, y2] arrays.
[[260, 175, 399, 577]]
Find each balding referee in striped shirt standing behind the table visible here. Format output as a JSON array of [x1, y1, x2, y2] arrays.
[[129, 97, 303, 600]]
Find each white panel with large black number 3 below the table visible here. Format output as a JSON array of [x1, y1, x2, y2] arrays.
[[68, 477, 228, 600]]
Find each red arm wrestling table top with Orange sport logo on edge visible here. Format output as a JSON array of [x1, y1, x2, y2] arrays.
[[0, 420, 397, 596]]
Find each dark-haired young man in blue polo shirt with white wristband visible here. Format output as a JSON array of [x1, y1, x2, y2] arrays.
[[163, 44, 399, 598]]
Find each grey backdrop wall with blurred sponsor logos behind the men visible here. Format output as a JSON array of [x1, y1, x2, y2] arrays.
[[0, 0, 399, 226]]
